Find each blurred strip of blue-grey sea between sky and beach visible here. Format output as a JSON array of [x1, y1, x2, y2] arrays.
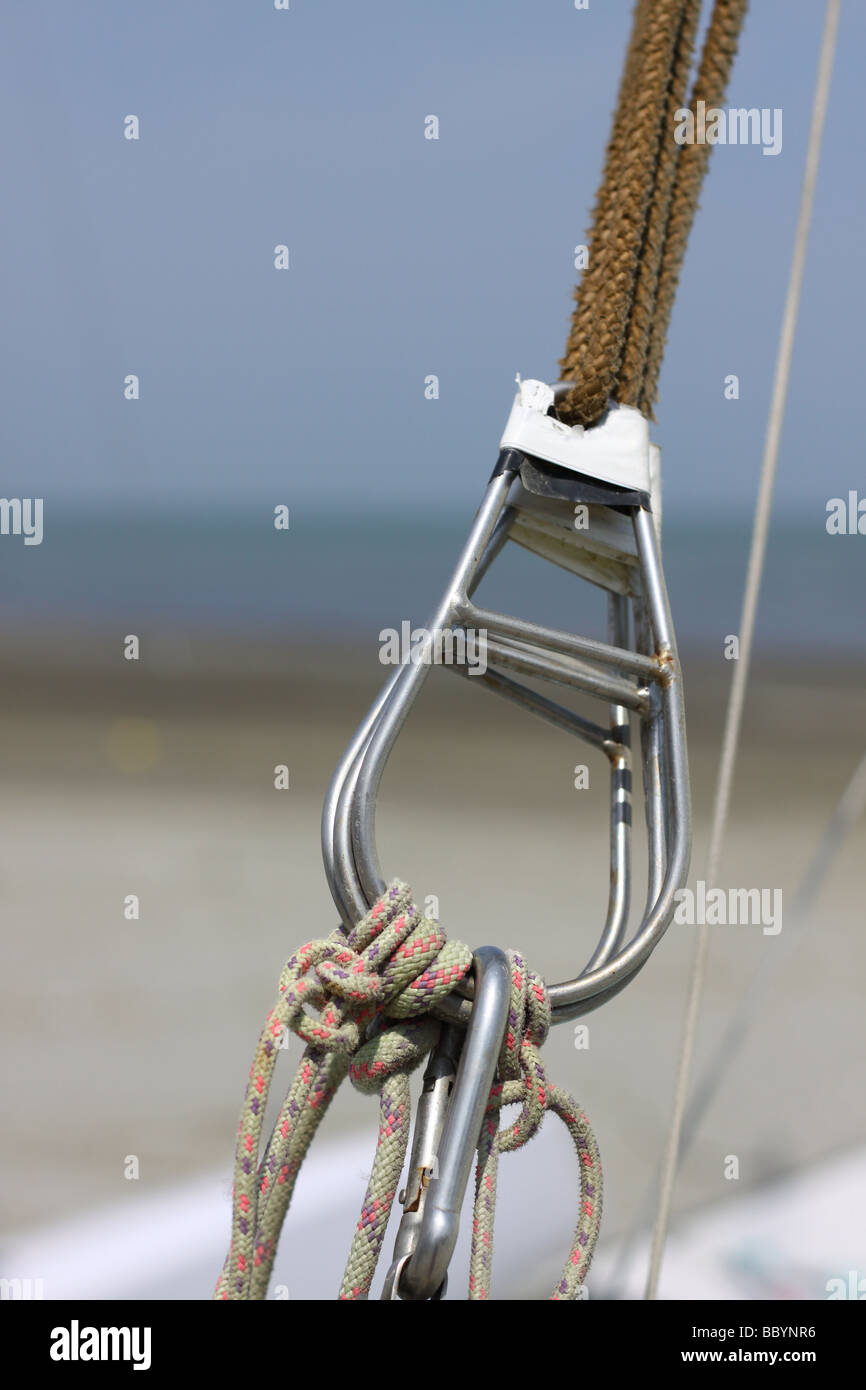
[[0, 507, 866, 662]]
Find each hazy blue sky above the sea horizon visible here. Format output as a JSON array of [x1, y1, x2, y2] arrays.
[[0, 0, 866, 516]]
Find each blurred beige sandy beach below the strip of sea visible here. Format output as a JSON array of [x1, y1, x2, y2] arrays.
[[0, 635, 866, 1278]]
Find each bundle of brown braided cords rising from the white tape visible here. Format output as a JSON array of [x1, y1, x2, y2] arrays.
[[557, 0, 748, 425]]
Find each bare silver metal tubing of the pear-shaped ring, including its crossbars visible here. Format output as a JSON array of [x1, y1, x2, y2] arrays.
[[322, 467, 691, 1022]]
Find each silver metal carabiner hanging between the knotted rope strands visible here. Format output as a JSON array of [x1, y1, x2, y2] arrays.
[[382, 947, 510, 1302]]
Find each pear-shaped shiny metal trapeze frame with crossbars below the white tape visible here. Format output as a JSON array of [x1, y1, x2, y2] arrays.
[[322, 448, 691, 1023]]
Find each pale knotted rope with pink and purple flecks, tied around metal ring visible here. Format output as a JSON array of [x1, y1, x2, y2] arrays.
[[215, 881, 602, 1300]]
